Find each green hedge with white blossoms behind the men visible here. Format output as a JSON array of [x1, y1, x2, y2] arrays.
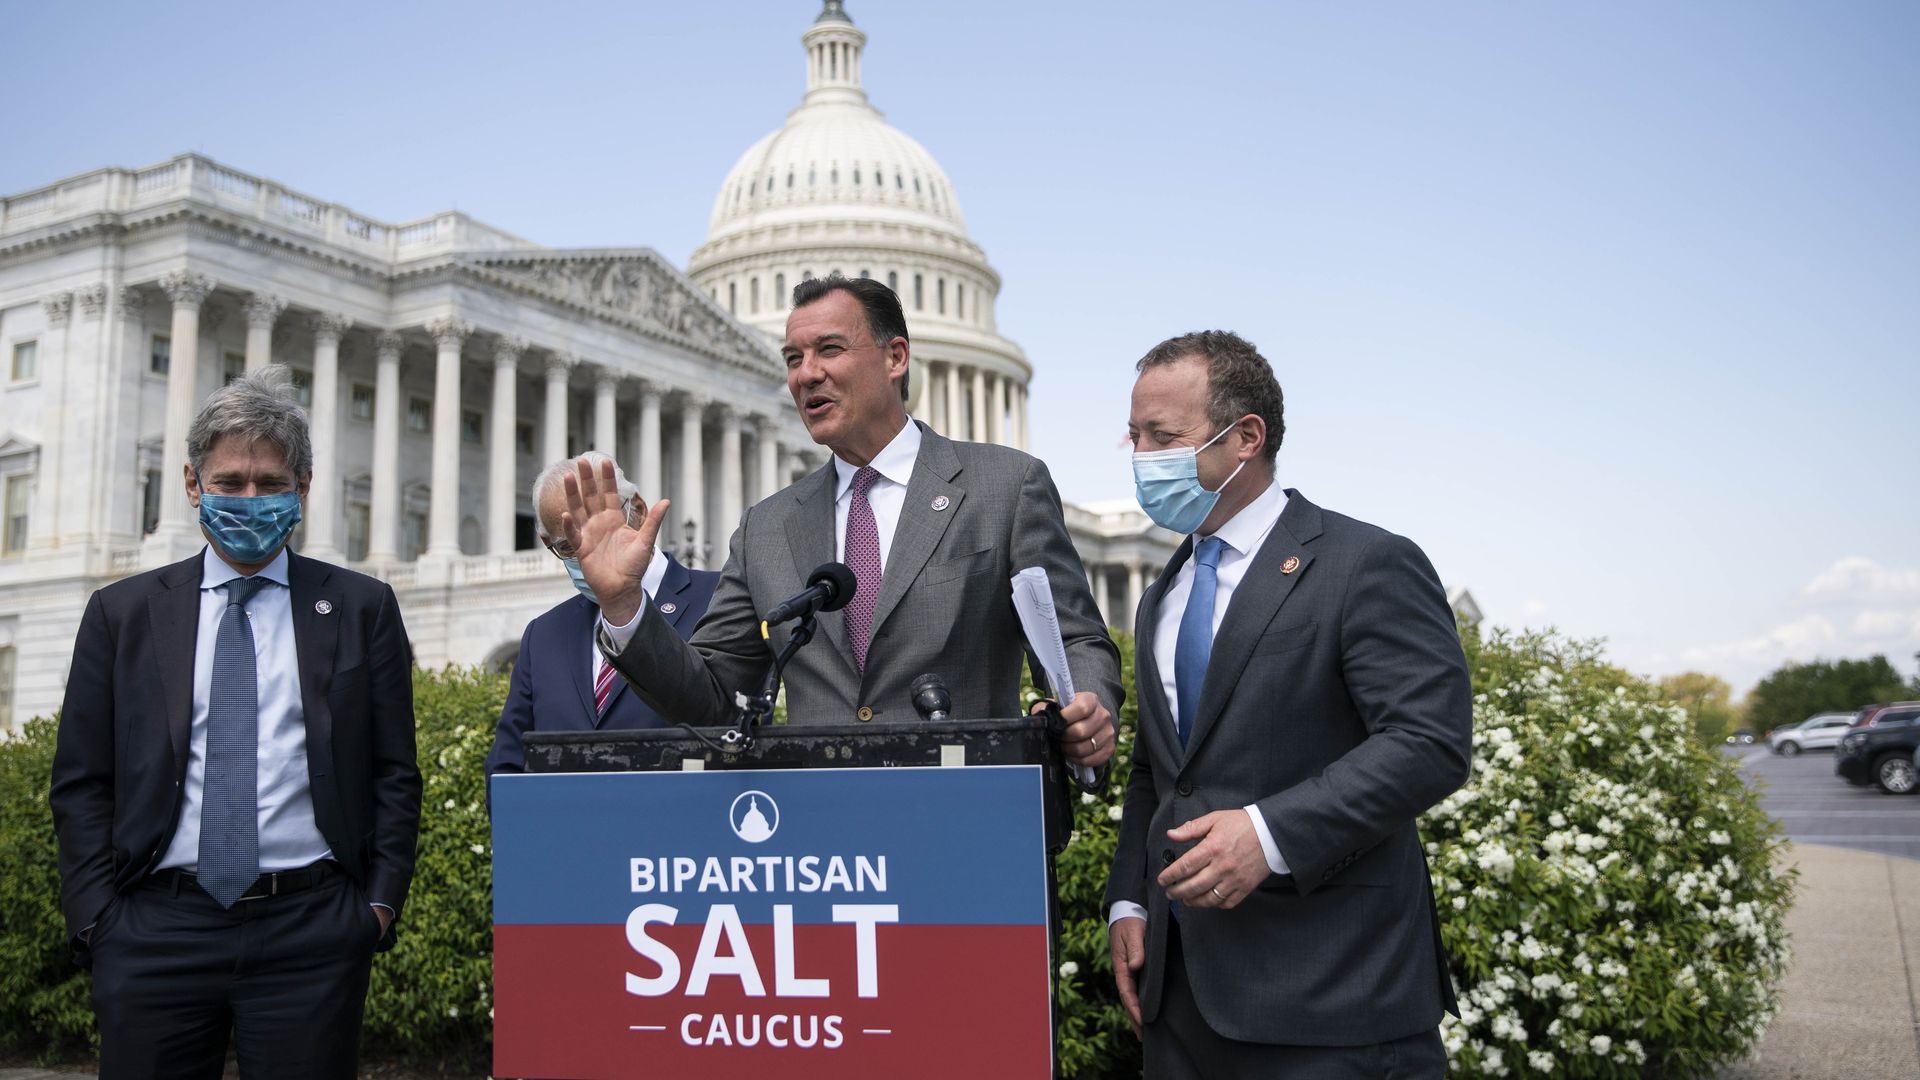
[[0, 622, 1791, 1078]]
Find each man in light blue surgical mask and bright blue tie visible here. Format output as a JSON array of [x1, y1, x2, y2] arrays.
[[1106, 331, 1473, 1080]]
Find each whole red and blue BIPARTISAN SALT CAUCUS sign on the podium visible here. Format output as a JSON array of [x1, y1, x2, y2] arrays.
[[493, 765, 1052, 1078]]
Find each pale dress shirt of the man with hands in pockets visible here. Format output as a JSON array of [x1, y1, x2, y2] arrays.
[[157, 546, 332, 872]]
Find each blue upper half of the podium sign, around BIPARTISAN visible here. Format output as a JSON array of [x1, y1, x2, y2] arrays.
[[493, 765, 1046, 926]]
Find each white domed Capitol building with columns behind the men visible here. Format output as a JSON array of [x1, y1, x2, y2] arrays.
[[0, 0, 1177, 730]]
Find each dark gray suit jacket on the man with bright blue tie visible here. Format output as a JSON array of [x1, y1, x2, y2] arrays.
[[1106, 490, 1473, 1045]]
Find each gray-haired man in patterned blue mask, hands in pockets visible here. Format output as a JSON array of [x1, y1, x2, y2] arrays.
[[48, 367, 420, 1080]]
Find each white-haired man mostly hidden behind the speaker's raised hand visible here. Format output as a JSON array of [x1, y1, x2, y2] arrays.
[[486, 450, 720, 774]]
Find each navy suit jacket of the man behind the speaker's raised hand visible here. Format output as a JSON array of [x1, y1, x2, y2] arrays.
[[486, 555, 720, 774]]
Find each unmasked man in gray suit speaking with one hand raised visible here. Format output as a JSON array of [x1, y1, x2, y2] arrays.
[[563, 275, 1121, 767]]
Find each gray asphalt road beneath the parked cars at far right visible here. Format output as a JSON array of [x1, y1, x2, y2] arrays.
[[1726, 744, 1920, 859]]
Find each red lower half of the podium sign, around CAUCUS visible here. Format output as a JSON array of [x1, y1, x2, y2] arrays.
[[493, 924, 1052, 1080]]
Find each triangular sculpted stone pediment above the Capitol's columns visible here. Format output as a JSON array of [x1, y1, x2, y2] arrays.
[[457, 248, 783, 377]]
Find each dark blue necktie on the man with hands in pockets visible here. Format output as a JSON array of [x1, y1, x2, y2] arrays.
[[194, 578, 271, 907]]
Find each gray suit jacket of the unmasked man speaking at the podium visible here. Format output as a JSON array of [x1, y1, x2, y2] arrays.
[[611, 417, 1121, 726]]
